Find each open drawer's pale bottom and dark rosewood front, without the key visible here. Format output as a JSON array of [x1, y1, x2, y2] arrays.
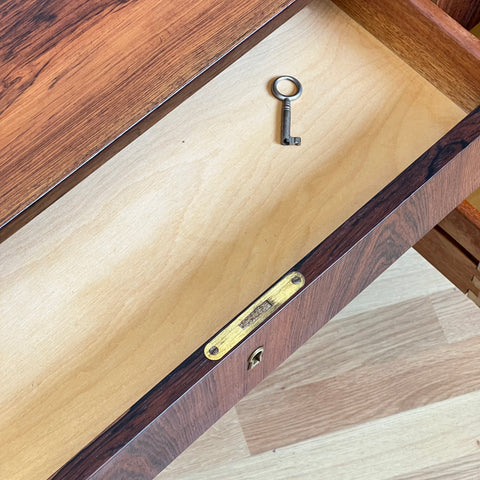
[[0, 0, 480, 480]]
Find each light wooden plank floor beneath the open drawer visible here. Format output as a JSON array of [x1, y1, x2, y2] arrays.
[[157, 250, 480, 480]]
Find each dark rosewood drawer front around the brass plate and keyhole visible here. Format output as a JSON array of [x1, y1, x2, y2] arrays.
[[52, 109, 480, 480]]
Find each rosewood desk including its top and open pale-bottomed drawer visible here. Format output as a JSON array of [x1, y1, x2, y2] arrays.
[[0, 0, 480, 480]]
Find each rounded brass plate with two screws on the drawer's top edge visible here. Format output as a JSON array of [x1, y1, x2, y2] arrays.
[[204, 272, 305, 360]]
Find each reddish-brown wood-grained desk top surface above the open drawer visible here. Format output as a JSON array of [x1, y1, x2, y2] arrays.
[[0, 0, 300, 234]]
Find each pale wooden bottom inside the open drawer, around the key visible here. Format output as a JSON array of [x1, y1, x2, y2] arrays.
[[0, 1, 464, 479]]
